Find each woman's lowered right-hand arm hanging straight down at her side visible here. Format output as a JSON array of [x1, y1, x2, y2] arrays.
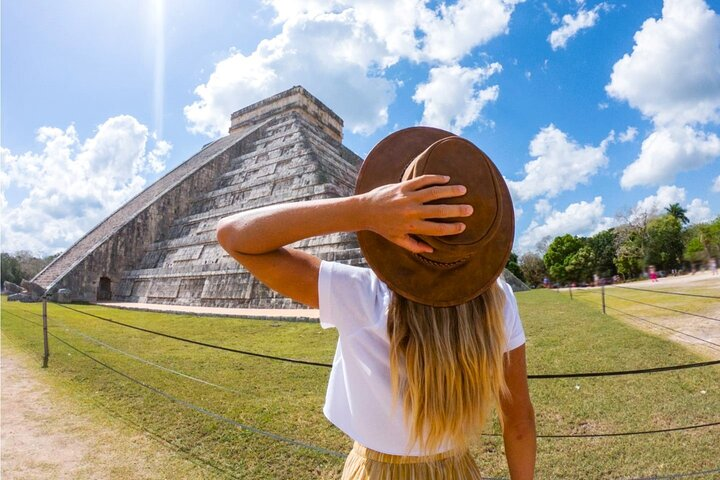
[[500, 345, 537, 480]]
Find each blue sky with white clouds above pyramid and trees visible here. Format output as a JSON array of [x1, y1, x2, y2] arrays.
[[0, 0, 720, 255]]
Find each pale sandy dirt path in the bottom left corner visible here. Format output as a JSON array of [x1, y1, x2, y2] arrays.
[[0, 339, 218, 480]]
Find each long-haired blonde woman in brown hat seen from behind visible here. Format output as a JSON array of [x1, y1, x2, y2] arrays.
[[217, 127, 536, 480]]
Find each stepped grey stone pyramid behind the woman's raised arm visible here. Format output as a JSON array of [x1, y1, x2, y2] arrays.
[[33, 87, 364, 308]]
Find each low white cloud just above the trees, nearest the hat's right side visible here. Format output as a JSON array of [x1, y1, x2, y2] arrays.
[[518, 196, 613, 252]]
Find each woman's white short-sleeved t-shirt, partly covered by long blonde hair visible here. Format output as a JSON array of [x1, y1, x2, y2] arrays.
[[318, 261, 525, 456]]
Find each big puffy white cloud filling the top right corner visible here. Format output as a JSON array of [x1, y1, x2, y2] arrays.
[[605, 0, 720, 125]]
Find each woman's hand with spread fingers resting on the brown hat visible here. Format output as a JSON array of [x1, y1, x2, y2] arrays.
[[361, 175, 473, 253]]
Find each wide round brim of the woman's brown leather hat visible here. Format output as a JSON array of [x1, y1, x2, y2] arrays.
[[355, 127, 515, 307]]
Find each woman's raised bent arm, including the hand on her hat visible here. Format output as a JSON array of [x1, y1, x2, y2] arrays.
[[217, 175, 472, 308]]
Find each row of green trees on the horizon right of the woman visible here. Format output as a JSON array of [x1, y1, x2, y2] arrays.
[[507, 203, 720, 287]]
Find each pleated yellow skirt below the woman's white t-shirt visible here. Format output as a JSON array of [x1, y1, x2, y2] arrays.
[[342, 442, 482, 480]]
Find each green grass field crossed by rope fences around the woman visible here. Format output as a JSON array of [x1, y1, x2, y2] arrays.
[[2, 291, 720, 479]]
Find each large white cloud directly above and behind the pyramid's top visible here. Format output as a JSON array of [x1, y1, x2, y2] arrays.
[[184, 0, 519, 137]]
